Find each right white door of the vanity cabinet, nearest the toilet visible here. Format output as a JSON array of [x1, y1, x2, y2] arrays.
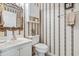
[[20, 43, 32, 56]]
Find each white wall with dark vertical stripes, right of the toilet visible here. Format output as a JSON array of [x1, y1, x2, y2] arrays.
[[41, 3, 79, 56]]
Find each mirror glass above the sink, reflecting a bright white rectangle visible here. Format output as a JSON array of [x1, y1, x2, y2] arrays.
[[0, 3, 23, 29]]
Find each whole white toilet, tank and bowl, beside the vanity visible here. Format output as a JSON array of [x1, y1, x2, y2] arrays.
[[27, 35, 48, 56]]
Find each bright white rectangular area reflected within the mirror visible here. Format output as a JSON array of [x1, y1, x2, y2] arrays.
[[2, 11, 16, 27]]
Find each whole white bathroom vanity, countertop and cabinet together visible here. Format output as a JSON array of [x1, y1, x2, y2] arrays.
[[0, 38, 32, 56]]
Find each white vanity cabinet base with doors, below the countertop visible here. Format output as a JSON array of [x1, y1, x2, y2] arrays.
[[0, 43, 32, 56]]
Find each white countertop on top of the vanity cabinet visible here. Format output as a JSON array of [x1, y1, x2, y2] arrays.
[[0, 38, 32, 52]]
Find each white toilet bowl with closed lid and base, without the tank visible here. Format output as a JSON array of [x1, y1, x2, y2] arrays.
[[34, 43, 48, 56]]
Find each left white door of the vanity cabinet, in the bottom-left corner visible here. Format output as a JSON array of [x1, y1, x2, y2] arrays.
[[1, 48, 19, 56]]
